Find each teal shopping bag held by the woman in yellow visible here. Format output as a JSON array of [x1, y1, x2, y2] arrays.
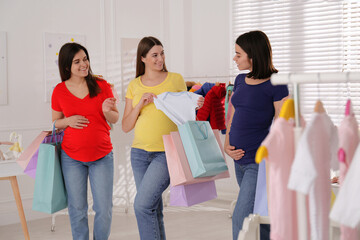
[[178, 121, 228, 178]]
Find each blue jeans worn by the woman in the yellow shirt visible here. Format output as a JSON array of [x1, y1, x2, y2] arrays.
[[131, 148, 170, 240]]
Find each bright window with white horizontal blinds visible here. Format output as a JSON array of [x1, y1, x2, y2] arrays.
[[231, 0, 360, 124]]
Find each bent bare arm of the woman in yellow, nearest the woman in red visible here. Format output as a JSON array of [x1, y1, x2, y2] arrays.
[[121, 93, 156, 133]]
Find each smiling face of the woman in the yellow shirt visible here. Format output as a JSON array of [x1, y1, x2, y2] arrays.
[[141, 45, 165, 71]]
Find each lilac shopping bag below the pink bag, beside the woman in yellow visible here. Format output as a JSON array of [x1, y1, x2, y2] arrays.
[[170, 181, 217, 207]]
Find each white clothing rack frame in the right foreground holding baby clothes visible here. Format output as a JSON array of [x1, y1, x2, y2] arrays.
[[271, 72, 360, 240]]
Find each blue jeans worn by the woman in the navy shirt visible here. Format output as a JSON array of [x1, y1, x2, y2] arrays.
[[232, 163, 259, 240]]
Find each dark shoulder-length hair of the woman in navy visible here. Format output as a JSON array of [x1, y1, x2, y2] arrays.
[[236, 31, 278, 79]]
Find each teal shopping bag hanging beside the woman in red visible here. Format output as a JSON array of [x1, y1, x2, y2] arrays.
[[32, 129, 67, 213]]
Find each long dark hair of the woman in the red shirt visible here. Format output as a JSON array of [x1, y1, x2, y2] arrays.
[[59, 42, 101, 97]]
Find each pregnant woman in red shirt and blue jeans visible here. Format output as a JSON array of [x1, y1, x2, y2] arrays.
[[51, 43, 119, 240]]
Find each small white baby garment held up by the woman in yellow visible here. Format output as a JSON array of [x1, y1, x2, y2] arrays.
[[154, 92, 201, 125]]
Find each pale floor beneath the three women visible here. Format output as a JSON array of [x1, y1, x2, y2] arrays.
[[0, 200, 232, 240]]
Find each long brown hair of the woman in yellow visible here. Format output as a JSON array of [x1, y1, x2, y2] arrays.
[[135, 36, 167, 78]]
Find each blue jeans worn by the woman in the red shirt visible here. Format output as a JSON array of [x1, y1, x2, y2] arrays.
[[61, 150, 114, 240]]
